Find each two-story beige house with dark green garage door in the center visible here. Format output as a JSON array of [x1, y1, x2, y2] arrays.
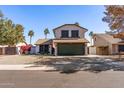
[[35, 24, 88, 55]]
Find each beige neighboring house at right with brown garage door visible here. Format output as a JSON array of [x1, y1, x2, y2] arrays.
[[93, 34, 124, 55]]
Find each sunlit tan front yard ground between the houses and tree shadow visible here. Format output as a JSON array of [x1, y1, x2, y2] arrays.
[[0, 55, 124, 65]]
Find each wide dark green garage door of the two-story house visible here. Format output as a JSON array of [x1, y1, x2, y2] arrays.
[[58, 44, 85, 55]]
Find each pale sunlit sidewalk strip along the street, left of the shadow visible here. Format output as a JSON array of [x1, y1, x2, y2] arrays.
[[0, 65, 56, 70]]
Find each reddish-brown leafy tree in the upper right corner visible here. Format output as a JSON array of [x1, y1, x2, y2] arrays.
[[102, 5, 124, 33]]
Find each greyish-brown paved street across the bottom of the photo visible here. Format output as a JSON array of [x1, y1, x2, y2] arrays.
[[0, 70, 124, 88]]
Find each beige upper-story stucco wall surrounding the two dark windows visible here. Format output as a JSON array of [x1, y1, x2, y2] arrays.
[[55, 25, 86, 39]]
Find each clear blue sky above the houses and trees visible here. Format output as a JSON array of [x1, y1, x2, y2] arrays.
[[0, 5, 109, 43]]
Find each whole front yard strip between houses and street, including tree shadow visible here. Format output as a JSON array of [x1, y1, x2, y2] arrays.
[[0, 55, 124, 73]]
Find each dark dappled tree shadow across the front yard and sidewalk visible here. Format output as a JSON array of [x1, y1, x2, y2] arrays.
[[25, 57, 124, 74]]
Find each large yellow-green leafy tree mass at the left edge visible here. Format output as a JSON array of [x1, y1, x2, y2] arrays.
[[0, 9, 25, 46]]
